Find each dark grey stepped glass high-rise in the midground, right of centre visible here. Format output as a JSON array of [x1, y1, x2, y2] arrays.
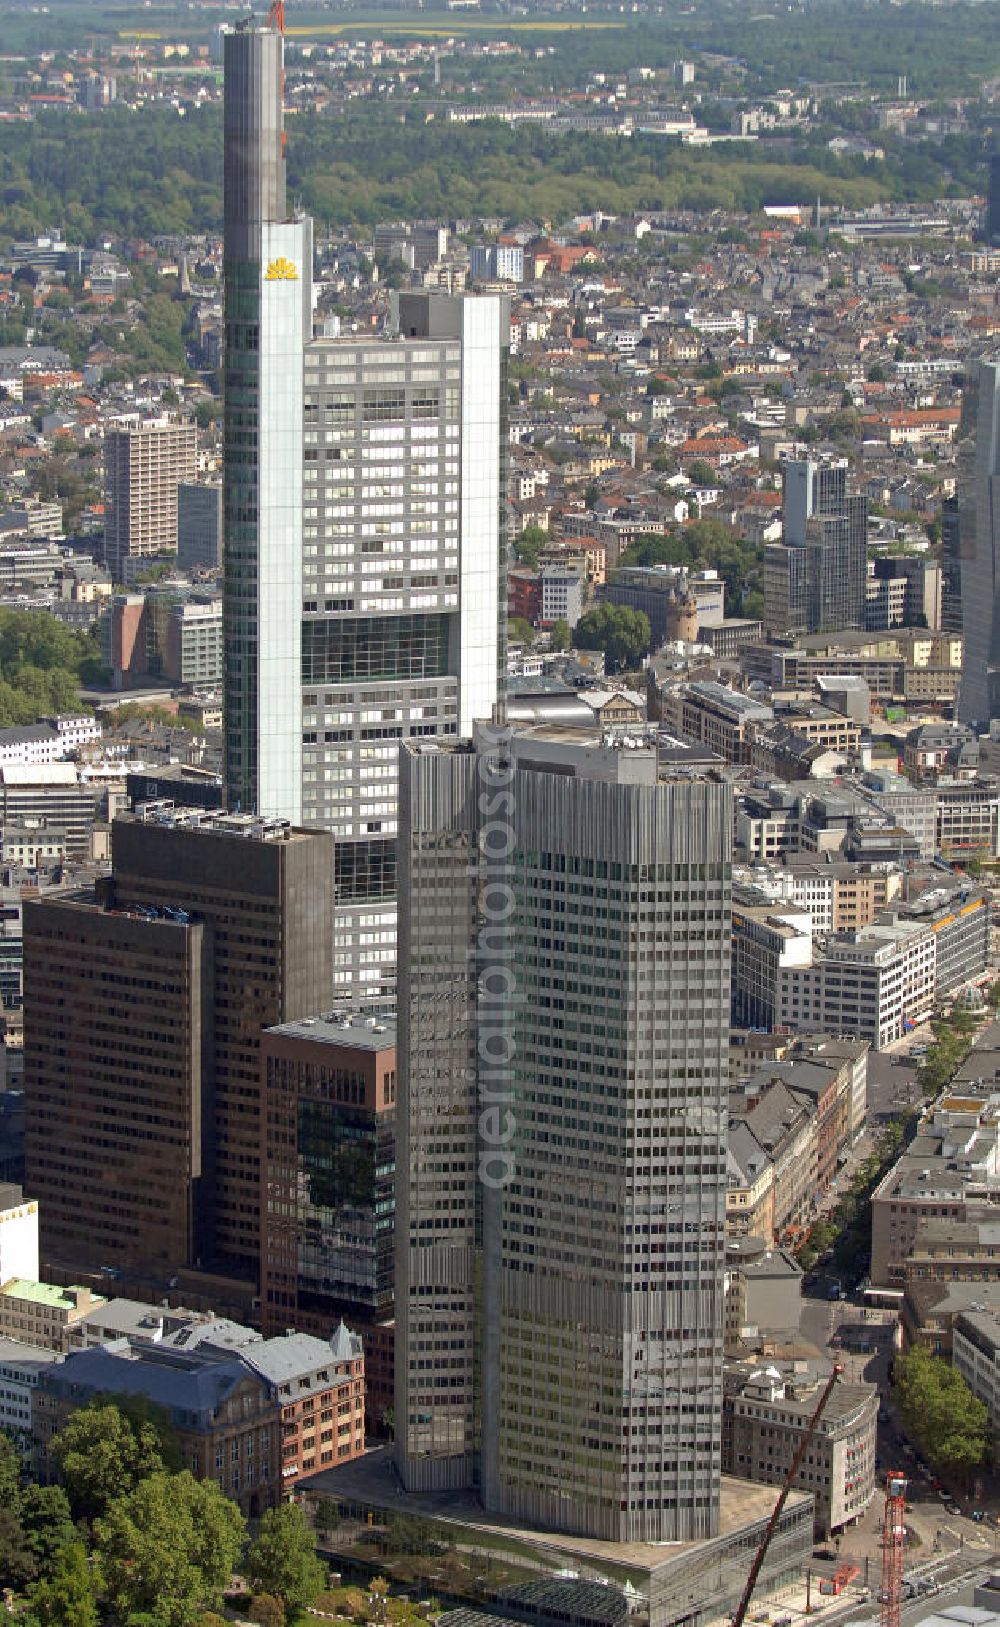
[[764, 459, 868, 633]]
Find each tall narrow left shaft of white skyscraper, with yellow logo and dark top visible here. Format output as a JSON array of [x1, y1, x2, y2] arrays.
[[223, 21, 312, 820]]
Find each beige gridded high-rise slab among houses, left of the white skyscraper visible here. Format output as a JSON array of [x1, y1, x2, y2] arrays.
[[104, 420, 197, 582]]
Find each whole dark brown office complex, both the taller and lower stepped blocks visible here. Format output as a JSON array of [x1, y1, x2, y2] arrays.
[[24, 805, 333, 1282]]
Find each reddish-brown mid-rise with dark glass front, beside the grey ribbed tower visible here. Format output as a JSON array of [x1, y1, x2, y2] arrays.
[[260, 1017, 395, 1429]]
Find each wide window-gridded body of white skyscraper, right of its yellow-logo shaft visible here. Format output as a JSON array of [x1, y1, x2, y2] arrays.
[[299, 293, 509, 1005]]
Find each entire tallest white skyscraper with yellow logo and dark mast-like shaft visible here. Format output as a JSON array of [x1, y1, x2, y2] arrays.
[[224, 24, 509, 1005]]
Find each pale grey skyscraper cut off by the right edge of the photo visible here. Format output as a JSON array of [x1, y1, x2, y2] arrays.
[[958, 361, 1000, 726]]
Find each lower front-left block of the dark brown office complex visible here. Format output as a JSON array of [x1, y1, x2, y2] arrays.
[[24, 893, 211, 1274]]
